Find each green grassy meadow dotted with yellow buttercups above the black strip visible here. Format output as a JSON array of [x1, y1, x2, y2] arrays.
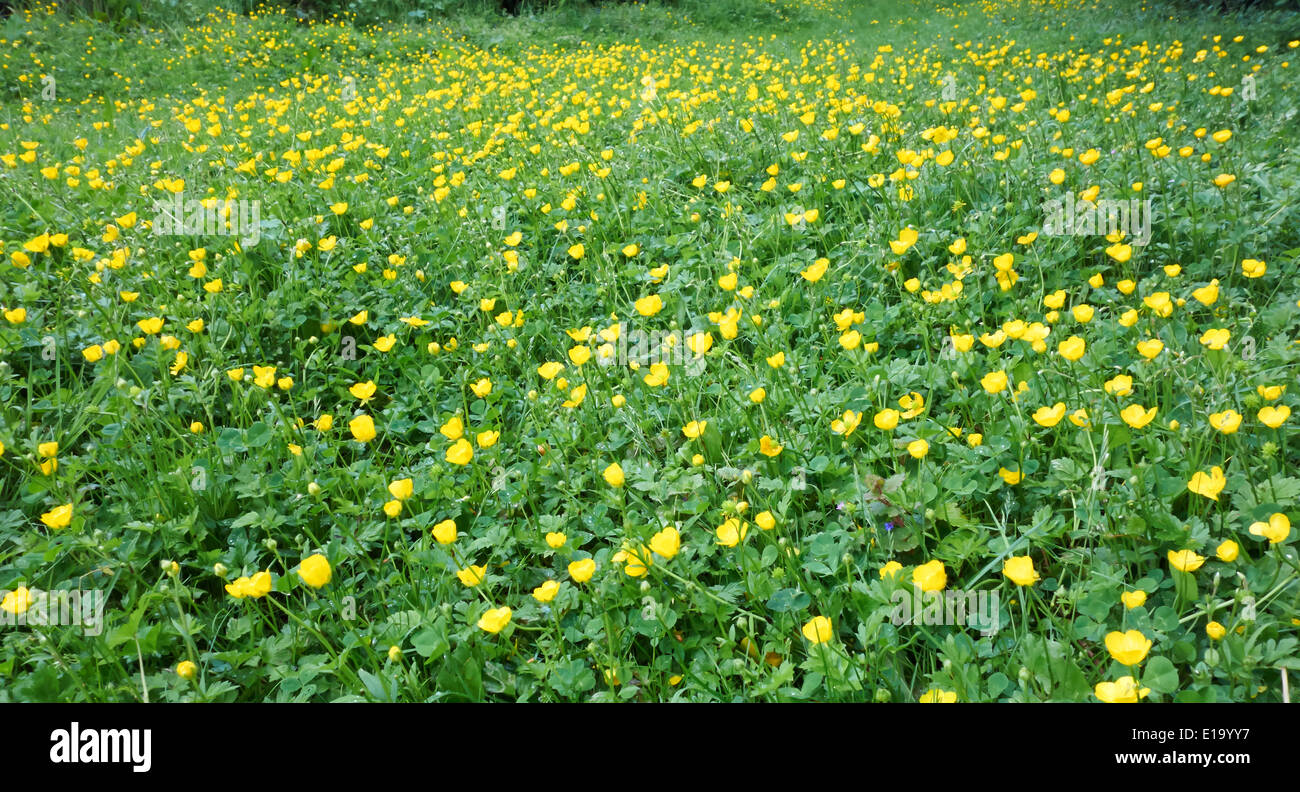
[[0, 0, 1300, 702]]
